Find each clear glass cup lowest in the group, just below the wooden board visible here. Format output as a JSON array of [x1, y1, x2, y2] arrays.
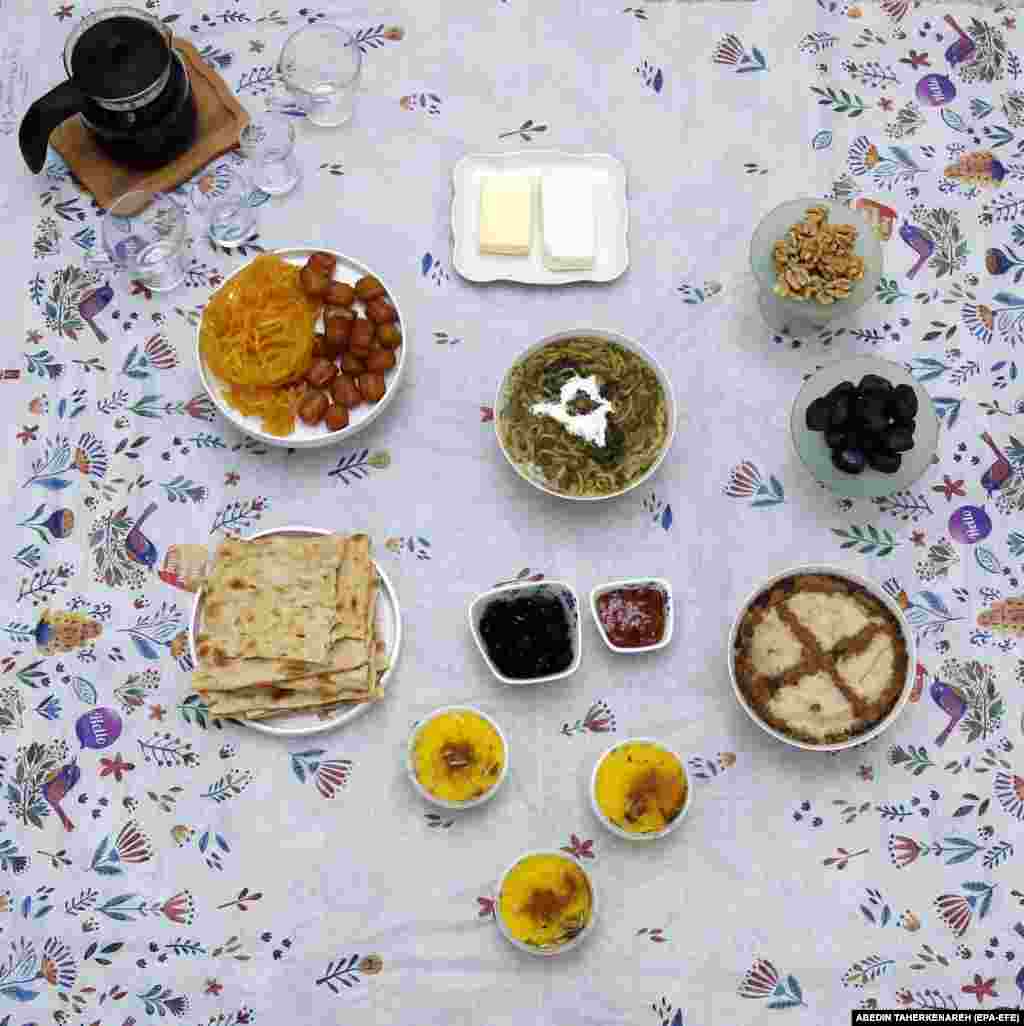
[[101, 190, 188, 292]]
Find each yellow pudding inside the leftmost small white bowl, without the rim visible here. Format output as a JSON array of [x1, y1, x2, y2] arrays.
[[412, 709, 505, 801]]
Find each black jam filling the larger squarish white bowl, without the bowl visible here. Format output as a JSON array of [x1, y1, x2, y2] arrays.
[[480, 595, 573, 680]]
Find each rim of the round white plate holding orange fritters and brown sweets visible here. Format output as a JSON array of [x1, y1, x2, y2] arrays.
[[193, 244, 409, 449]]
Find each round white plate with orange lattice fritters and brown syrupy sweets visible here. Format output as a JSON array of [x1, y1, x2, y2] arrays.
[[195, 246, 408, 448]]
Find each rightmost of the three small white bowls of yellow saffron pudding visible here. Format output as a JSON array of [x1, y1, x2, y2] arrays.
[[590, 738, 691, 840]]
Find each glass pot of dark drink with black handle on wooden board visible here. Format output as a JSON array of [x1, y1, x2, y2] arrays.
[[17, 7, 197, 172]]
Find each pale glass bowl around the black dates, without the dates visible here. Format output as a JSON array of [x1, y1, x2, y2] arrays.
[[790, 356, 939, 499]]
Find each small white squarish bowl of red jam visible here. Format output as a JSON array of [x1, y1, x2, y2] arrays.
[[590, 578, 675, 655]]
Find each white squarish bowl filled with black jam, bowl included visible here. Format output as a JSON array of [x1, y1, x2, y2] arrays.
[[469, 581, 583, 685]]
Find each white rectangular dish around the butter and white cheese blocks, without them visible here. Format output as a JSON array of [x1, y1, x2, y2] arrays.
[[449, 149, 629, 285]]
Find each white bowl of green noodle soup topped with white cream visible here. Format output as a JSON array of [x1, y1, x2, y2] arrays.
[[495, 328, 675, 501]]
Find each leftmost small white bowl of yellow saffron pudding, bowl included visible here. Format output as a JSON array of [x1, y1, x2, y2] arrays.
[[405, 706, 509, 808]]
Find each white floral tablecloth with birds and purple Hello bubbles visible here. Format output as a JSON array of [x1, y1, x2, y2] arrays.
[[0, 0, 1024, 1026]]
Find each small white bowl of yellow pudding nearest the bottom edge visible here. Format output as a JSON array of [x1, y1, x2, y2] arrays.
[[495, 852, 597, 956]]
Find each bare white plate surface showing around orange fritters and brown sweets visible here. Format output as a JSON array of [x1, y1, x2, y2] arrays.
[[195, 246, 409, 448]]
